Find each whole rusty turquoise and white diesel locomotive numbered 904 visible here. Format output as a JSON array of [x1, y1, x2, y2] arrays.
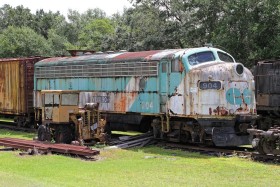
[[34, 47, 257, 146]]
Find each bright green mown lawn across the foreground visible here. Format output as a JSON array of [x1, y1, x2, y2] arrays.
[[0, 130, 280, 187]]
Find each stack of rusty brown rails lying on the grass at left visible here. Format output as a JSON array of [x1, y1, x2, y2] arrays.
[[0, 138, 100, 156]]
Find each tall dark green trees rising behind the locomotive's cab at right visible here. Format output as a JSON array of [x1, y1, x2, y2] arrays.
[[131, 0, 280, 66]]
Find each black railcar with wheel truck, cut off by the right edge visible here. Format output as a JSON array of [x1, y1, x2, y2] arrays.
[[248, 60, 280, 155]]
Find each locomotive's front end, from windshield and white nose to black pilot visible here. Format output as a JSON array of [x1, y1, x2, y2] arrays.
[[177, 48, 257, 146]]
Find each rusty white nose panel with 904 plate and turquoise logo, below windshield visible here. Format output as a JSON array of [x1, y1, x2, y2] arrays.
[[186, 63, 256, 116]]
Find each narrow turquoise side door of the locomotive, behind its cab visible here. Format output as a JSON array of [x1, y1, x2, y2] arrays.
[[159, 60, 170, 113]]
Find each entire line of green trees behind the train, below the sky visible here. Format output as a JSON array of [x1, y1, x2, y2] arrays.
[[0, 0, 280, 66]]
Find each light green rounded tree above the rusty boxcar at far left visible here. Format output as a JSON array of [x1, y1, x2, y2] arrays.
[[0, 26, 51, 58]]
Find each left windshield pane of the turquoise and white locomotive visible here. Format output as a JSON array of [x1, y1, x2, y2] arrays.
[[188, 51, 215, 65]]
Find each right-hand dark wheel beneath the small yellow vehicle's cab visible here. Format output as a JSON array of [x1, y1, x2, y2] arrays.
[[55, 125, 72, 144]]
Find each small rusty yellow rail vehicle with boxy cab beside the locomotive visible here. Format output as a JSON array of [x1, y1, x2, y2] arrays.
[[36, 90, 108, 145]]
